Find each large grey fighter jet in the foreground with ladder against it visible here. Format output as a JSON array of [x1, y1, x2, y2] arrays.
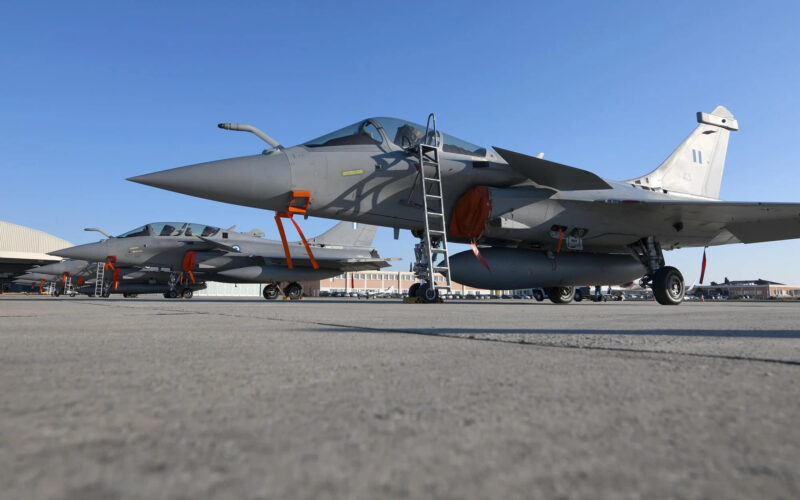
[[128, 106, 800, 305]]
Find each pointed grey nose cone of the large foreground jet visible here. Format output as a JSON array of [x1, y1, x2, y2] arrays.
[[128, 151, 292, 210]]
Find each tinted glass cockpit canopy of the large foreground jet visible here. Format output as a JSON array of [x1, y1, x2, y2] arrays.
[[303, 117, 486, 156]]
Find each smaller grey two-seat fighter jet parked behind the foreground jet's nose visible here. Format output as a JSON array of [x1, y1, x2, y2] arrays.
[[51, 222, 390, 299]]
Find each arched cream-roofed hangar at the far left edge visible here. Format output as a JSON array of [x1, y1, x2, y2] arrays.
[[0, 221, 72, 290]]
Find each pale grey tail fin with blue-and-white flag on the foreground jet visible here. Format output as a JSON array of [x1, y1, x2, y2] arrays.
[[629, 106, 739, 198]]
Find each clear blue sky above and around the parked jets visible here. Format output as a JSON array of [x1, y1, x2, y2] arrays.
[[0, 0, 800, 283]]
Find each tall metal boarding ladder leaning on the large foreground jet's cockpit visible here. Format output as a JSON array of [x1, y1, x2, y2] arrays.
[[411, 113, 451, 293]]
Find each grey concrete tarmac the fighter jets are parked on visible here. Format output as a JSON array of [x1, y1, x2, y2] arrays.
[[0, 296, 800, 499]]
